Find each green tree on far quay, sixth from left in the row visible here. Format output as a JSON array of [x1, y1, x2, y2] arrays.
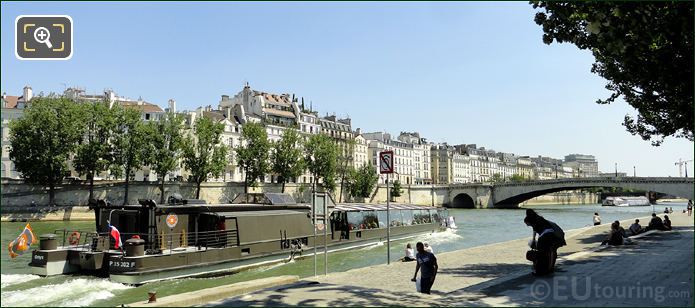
[[236, 122, 270, 194]]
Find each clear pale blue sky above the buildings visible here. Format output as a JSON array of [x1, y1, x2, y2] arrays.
[[0, 2, 695, 176]]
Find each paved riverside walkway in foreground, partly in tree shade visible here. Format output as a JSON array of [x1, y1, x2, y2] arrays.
[[209, 213, 693, 306]]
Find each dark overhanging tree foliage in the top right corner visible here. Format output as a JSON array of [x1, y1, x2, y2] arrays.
[[531, 1, 693, 146]]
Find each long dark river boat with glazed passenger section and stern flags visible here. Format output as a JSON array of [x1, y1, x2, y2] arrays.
[[29, 193, 448, 284]]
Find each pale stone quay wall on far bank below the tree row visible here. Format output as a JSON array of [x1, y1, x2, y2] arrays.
[[1, 180, 598, 208]]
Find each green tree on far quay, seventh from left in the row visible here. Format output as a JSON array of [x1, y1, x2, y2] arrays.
[[271, 128, 304, 193]]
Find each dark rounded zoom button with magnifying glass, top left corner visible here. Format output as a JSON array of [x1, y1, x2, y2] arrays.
[[15, 15, 72, 60]]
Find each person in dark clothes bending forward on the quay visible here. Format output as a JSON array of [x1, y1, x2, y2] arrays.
[[524, 209, 567, 276]]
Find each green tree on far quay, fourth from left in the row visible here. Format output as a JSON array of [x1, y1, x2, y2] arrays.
[[147, 112, 184, 203]]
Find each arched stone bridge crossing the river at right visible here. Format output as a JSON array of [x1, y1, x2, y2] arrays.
[[446, 177, 695, 208]]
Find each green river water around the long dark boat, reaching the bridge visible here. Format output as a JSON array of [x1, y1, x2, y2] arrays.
[[0, 203, 685, 307]]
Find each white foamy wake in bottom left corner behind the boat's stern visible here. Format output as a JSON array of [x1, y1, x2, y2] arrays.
[[1, 275, 132, 307]]
